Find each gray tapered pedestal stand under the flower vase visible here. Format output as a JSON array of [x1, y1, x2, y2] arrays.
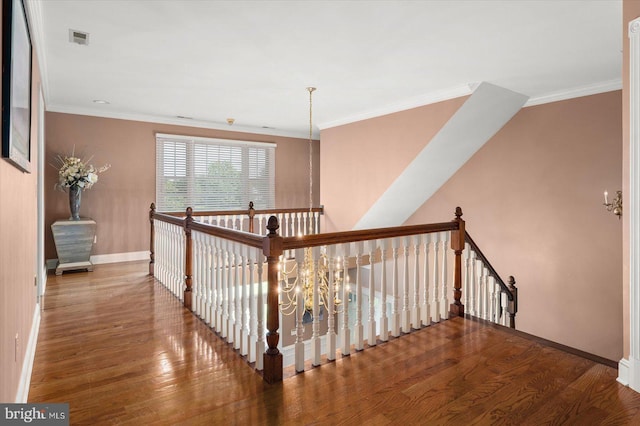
[[51, 218, 96, 275]]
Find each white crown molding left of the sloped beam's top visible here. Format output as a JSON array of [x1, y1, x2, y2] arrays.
[[318, 83, 477, 130]]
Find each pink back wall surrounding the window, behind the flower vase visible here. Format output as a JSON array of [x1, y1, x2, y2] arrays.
[[45, 112, 320, 259]]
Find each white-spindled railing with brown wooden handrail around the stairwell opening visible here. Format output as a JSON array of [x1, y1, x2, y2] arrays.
[[150, 204, 517, 380]]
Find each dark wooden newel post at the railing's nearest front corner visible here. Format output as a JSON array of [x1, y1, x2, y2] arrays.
[[262, 216, 282, 383]]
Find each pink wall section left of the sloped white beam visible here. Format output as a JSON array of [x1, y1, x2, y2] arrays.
[[320, 98, 466, 232]]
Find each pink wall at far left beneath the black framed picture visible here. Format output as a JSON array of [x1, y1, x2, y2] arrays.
[[0, 46, 40, 402]]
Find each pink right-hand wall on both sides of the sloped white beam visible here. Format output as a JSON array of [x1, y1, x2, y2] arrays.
[[321, 92, 622, 361]]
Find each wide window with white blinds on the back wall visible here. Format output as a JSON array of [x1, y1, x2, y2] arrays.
[[156, 133, 276, 212]]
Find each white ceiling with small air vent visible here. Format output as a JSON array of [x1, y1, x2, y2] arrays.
[[26, 0, 626, 137]]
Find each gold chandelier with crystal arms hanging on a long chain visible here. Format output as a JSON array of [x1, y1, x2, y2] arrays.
[[278, 87, 349, 316]]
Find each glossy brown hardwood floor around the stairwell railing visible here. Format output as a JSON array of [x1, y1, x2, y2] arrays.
[[29, 262, 640, 425]]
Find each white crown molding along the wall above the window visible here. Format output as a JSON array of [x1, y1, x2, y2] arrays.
[[47, 105, 320, 139]]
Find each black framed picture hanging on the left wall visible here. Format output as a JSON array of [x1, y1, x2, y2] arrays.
[[2, 0, 31, 173]]
